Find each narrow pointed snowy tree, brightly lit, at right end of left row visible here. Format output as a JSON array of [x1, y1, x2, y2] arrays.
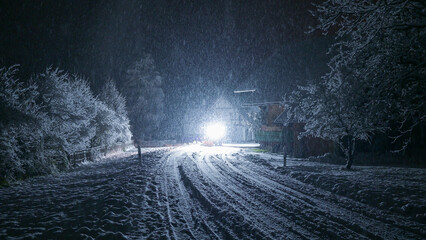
[[94, 79, 131, 146]]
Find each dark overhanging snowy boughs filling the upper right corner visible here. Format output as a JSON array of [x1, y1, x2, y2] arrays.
[[313, 0, 426, 148]]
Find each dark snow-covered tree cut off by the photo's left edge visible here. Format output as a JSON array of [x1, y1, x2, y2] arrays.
[[0, 65, 41, 181]]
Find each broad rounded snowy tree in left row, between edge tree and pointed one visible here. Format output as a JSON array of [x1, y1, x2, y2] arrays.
[[35, 68, 98, 164]]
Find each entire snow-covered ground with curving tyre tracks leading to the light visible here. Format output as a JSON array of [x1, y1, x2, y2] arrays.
[[0, 145, 426, 239]]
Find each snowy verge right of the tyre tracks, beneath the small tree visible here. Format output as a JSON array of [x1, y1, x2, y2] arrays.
[[243, 152, 426, 224]]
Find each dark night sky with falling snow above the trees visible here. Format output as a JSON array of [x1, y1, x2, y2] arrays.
[[0, 0, 326, 131]]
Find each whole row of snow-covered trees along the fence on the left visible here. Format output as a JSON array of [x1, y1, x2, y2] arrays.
[[0, 66, 130, 181]]
